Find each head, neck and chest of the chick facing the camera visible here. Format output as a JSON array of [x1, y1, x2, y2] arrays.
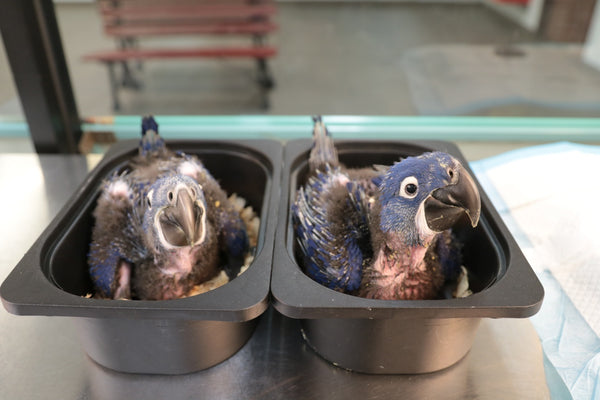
[[132, 175, 221, 299]]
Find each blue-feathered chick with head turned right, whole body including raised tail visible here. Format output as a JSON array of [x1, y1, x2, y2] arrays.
[[293, 118, 481, 300]]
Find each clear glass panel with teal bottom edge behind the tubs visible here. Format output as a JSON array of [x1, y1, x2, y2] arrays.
[[0, 0, 600, 150]]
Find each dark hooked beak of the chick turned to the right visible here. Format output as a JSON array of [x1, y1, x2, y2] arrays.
[[425, 165, 481, 232]]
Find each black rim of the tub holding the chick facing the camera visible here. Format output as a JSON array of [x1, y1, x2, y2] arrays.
[[0, 139, 283, 322]]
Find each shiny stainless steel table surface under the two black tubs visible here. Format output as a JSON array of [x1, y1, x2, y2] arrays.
[[0, 154, 549, 400]]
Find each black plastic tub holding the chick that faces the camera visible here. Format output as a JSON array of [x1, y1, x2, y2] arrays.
[[0, 140, 282, 374]]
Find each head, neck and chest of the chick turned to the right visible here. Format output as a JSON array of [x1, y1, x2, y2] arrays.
[[361, 152, 481, 299]]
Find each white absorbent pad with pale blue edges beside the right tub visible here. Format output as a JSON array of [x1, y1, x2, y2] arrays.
[[471, 143, 600, 399]]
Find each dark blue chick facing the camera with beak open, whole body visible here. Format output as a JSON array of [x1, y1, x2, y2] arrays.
[[88, 117, 248, 300]]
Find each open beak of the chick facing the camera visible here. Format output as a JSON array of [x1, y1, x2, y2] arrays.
[[158, 187, 204, 247]]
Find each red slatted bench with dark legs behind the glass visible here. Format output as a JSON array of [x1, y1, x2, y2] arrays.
[[84, 0, 277, 110]]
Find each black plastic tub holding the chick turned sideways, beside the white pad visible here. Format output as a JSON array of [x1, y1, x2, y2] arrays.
[[271, 140, 544, 374]]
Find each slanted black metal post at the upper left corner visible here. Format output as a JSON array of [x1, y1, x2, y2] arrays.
[[0, 0, 81, 153]]
